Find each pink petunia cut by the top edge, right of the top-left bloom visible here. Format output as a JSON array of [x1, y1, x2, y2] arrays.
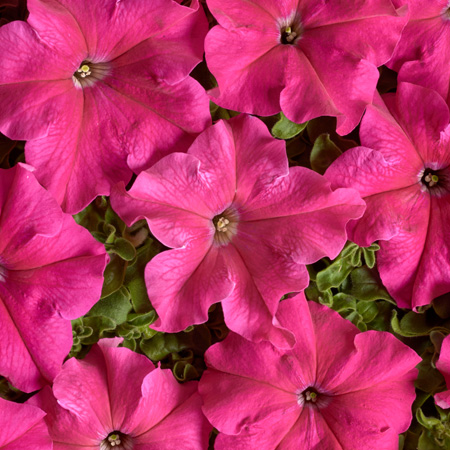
[[205, 0, 406, 134]]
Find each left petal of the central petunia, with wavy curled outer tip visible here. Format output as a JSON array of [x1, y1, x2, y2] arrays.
[[111, 153, 216, 247]]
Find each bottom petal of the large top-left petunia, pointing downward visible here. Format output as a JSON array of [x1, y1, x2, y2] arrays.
[[26, 85, 133, 214]]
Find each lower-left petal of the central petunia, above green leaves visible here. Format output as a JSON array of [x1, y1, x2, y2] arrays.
[[145, 240, 234, 333]]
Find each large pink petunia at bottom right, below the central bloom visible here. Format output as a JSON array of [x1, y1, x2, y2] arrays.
[[199, 293, 420, 450]]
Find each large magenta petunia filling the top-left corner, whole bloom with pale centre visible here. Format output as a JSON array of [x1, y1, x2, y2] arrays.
[[0, 0, 211, 213]]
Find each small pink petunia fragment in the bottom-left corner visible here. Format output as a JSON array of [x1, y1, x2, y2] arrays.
[[0, 397, 53, 450]]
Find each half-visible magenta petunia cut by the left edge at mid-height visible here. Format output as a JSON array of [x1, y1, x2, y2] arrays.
[[0, 165, 108, 392]]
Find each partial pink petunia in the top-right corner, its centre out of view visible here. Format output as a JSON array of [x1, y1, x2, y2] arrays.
[[387, 0, 450, 103]]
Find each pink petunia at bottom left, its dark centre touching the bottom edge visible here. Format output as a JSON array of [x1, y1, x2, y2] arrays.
[[31, 339, 212, 450]]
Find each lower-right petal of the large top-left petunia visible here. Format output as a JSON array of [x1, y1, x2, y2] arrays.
[[102, 73, 211, 172]]
